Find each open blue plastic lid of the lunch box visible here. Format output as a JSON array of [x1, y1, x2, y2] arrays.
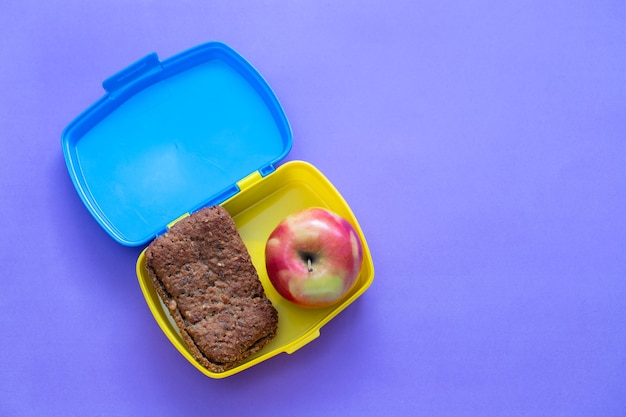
[[62, 42, 292, 246]]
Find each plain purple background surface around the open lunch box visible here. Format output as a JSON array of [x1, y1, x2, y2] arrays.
[[0, 0, 626, 416]]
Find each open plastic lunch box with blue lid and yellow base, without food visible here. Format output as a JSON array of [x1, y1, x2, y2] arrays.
[[62, 42, 374, 378]]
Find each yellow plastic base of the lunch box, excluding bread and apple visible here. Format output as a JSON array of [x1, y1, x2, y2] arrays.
[[137, 161, 374, 378]]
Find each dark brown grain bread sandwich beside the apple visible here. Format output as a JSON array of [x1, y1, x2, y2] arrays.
[[146, 206, 278, 372]]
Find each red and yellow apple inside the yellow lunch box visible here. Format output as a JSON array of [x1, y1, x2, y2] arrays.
[[265, 208, 363, 307]]
